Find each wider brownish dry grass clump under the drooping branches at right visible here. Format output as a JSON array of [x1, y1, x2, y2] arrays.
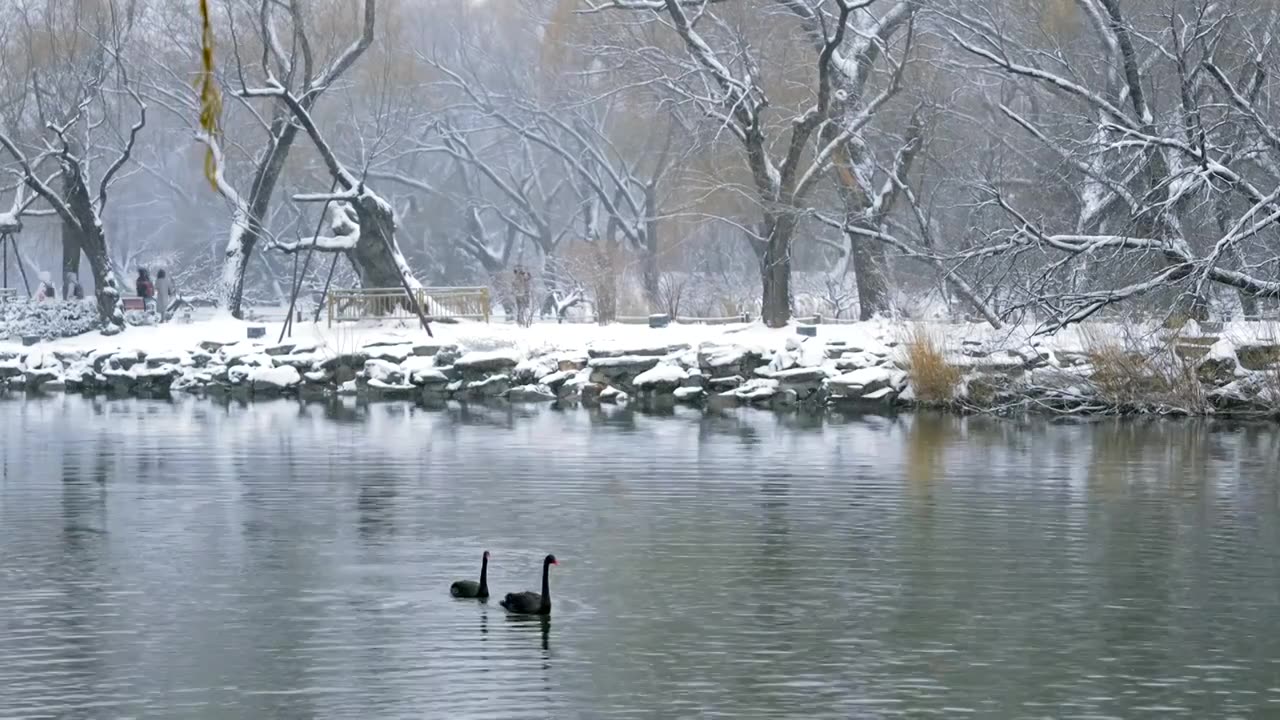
[[1080, 327, 1211, 415]]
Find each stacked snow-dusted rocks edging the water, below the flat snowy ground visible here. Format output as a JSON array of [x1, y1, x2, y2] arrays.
[[0, 326, 1280, 415]]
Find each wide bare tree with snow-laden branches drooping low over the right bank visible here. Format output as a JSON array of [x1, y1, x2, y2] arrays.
[[940, 0, 1280, 331]]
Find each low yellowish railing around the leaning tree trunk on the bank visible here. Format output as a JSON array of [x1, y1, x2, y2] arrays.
[[328, 287, 489, 327]]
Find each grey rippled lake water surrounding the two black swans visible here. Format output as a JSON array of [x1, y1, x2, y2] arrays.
[[0, 396, 1280, 719]]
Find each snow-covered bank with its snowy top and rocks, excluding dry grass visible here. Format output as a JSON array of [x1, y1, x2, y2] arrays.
[[0, 319, 1280, 414]]
